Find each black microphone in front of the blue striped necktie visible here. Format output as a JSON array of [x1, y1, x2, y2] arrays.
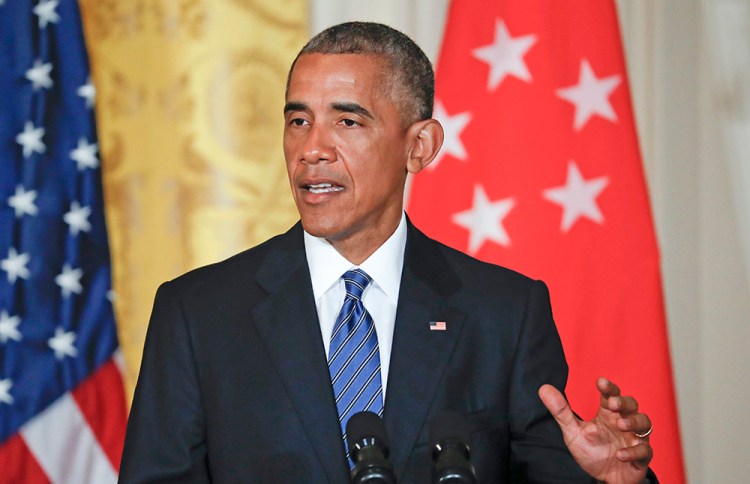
[[346, 412, 396, 484]]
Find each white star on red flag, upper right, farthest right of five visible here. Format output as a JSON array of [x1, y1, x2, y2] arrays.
[[557, 59, 622, 131]]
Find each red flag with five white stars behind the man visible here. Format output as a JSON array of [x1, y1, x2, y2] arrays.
[[408, 0, 685, 483]]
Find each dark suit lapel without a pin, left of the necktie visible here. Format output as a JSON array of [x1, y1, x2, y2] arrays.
[[253, 224, 349, 482]]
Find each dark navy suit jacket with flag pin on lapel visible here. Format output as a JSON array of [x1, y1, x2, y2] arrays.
[[120, 224, 591, 483]]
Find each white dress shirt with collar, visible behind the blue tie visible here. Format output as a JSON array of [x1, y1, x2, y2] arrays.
[[305, 213, 406, 402]]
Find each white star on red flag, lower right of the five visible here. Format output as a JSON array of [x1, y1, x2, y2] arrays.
[[544, 161, 609, 232]]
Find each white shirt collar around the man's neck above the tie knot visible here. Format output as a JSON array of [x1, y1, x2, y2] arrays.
[[304, 212, 406, 304]]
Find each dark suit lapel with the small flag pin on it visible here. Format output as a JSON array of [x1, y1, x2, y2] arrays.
[[384, 223, 465, 475]]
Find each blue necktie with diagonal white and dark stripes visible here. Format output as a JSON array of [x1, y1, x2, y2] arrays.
[[328, 269, 383, 465]]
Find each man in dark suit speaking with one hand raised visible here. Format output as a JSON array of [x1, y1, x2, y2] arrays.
[[121, 23, 652, 483]]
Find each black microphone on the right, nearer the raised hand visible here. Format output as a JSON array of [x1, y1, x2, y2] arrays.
[[430, 410, 477, 484]]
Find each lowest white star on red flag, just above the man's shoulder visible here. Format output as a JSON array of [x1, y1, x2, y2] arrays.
[[453, 184, 516, 254]]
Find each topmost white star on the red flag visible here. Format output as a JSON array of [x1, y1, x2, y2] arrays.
[[473, 19, 536, 91]]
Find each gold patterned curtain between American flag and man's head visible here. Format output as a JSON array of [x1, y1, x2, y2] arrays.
[[81, 0, 308, 395]]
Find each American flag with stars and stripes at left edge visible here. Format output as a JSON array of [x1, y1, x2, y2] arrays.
[[0, 0, 126, 483]]
